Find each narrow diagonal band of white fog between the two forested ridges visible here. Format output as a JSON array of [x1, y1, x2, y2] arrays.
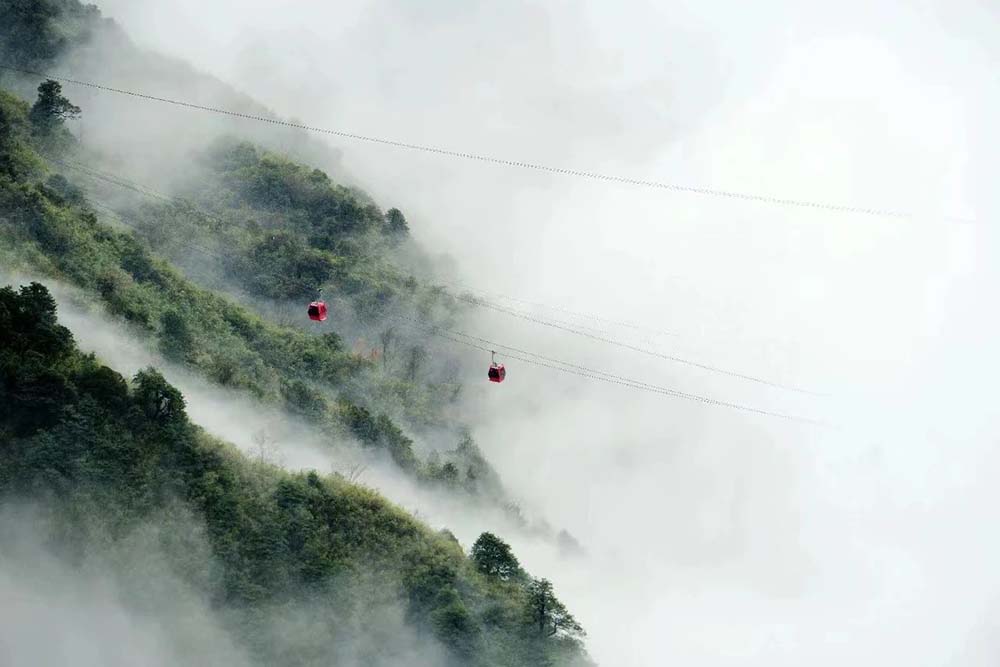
[[0, 274, 555, 549]]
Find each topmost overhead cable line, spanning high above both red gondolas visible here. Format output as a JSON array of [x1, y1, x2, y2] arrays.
[[0, 64, 976, 223]]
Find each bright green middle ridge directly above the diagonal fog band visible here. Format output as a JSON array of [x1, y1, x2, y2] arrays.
[[0, 85, 501, 494]]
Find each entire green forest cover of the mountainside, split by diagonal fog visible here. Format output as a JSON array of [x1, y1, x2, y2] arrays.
[[0, 0, 586, 665]]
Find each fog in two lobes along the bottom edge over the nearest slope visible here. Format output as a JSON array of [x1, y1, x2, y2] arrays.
[[0, 502, 454, 667]]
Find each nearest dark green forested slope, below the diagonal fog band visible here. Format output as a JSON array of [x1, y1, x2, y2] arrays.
[[0, 283, 580, 665]]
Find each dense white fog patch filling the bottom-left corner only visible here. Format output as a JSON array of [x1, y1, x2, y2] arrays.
[[0, 504, 250, 667]]
